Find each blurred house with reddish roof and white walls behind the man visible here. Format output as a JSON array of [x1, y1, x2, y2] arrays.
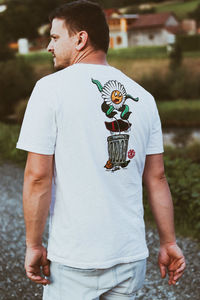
[[107, 12, 183, 48]]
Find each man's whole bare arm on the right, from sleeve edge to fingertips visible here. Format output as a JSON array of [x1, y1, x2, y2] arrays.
[[143, 154, 185, 284]]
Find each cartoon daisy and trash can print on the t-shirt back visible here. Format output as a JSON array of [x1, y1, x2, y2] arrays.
[[92, 79, 139, 172]]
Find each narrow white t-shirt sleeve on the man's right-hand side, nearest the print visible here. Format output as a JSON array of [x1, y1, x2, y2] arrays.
[[146, 100, 164, 155]]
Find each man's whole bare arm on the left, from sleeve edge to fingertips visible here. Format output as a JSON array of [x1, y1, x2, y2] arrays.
[[23, 152, 54, 285]]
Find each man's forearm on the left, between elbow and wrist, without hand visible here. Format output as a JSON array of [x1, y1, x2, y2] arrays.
[[23, 174, 52, 247]]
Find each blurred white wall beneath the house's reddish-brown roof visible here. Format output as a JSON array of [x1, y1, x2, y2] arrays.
[[128, 29, 175, 47]]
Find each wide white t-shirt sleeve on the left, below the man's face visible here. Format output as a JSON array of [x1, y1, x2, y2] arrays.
[[16, 80, 57, 155]]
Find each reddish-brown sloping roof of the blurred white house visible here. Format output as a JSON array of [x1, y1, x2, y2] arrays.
[[129, 12, 176, 29]]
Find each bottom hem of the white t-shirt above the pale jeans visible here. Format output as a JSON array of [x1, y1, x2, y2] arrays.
[[47, 251, 149, 269]]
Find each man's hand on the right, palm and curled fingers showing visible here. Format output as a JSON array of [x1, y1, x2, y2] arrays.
[[158, 243, 186, 285]]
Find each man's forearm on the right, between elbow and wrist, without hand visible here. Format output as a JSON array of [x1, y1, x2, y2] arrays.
[[147, 176, 176, 244]]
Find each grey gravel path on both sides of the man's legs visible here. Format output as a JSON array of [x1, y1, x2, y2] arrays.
[[0, 164, 200, 300]]
